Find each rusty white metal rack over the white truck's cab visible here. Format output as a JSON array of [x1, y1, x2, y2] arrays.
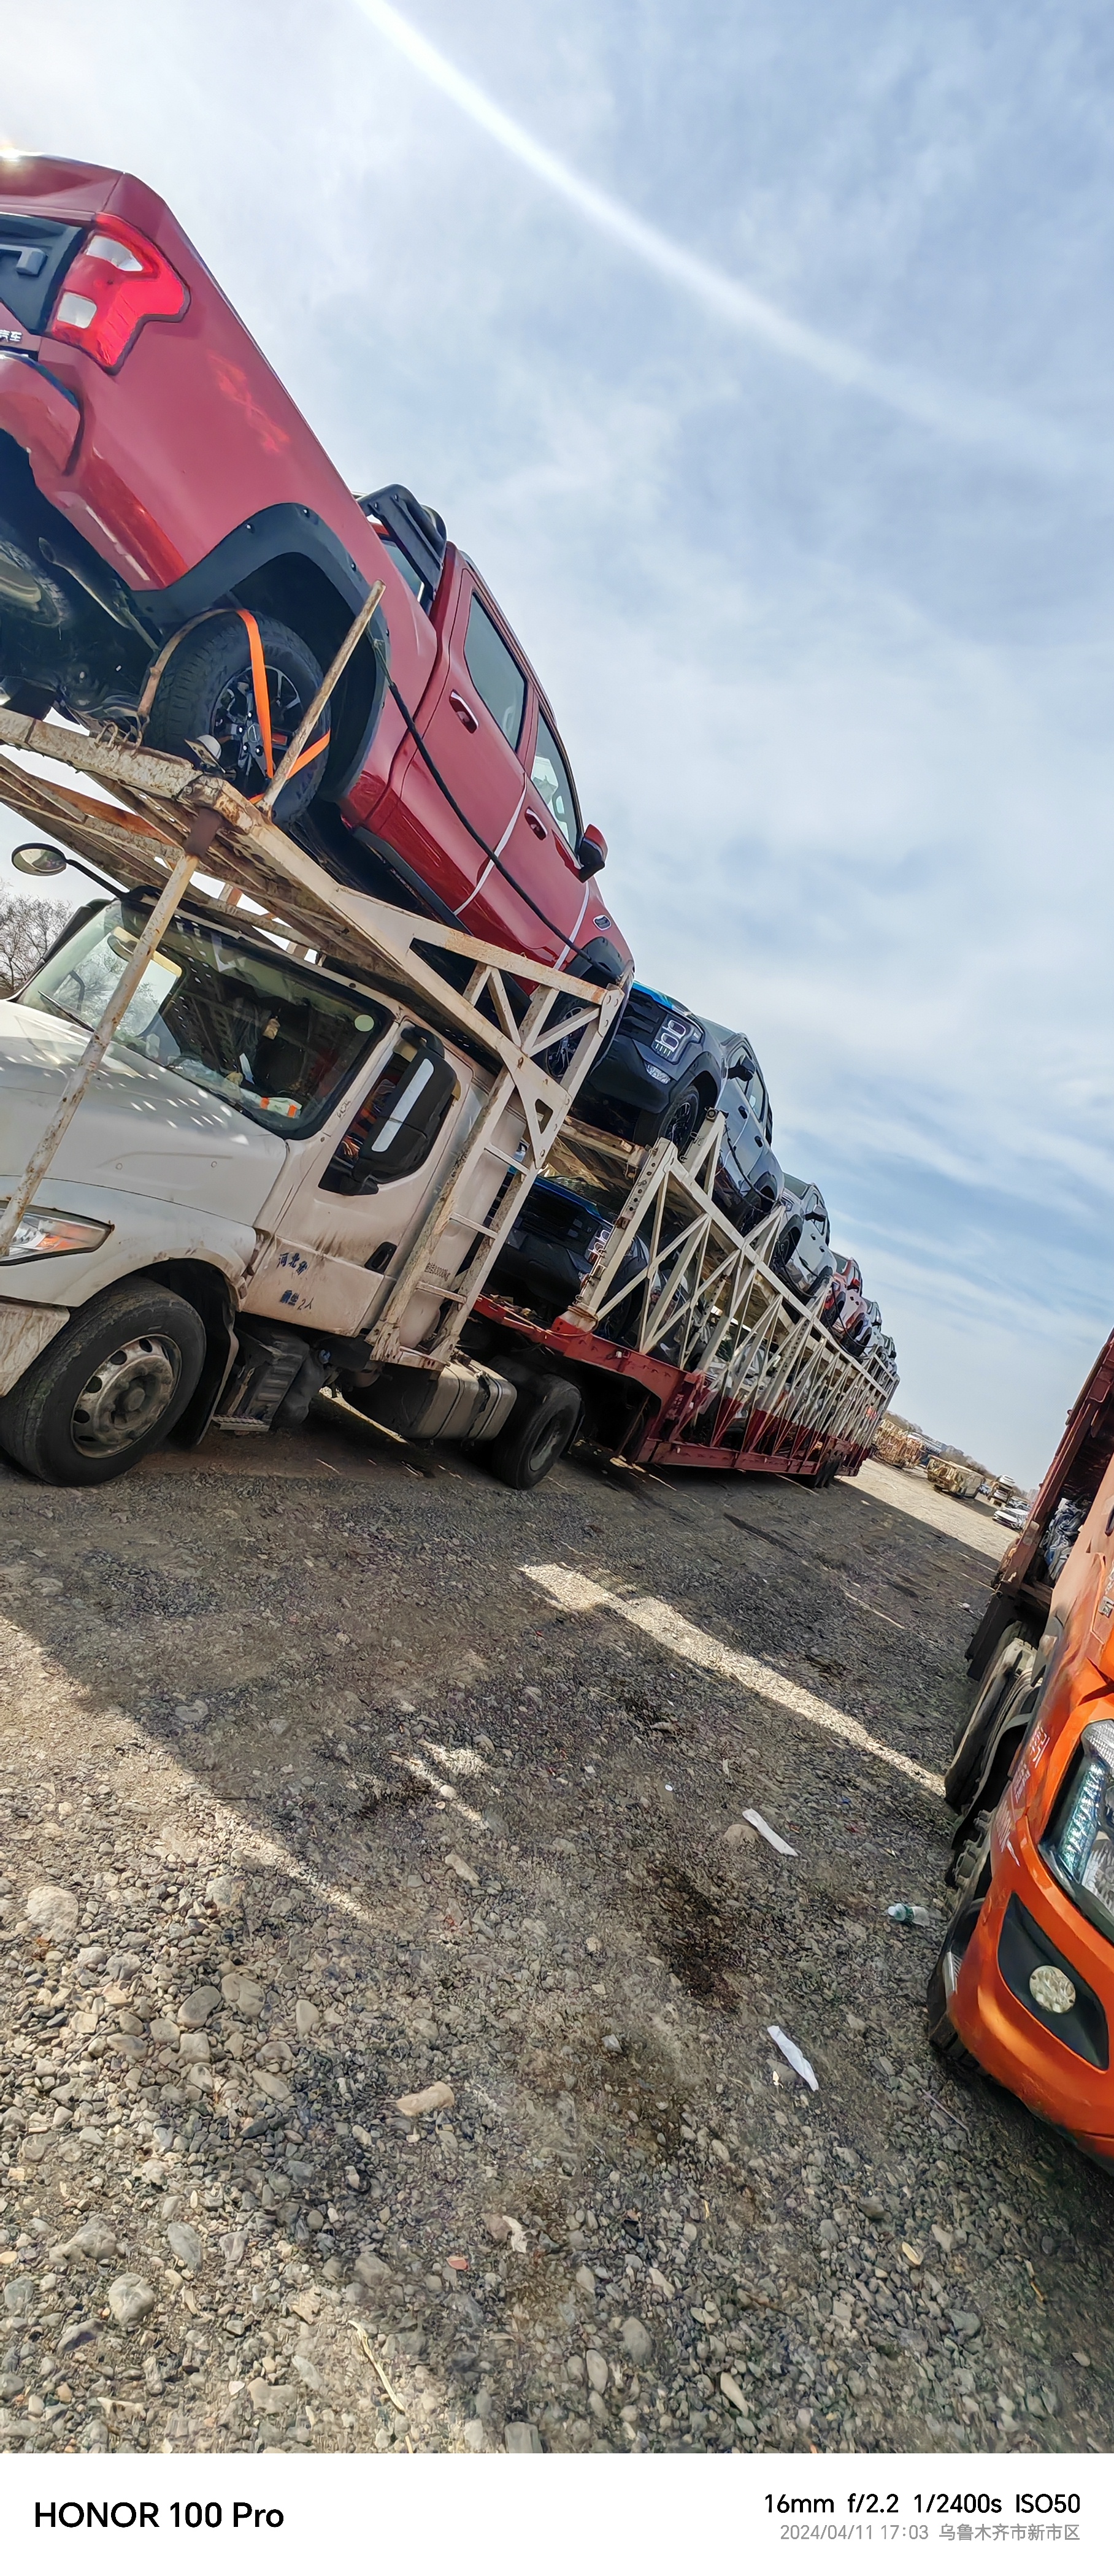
[[0, 696, 627, 1368]]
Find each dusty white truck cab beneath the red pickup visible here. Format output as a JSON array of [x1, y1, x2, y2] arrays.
[[0, 894, 564, 1484]]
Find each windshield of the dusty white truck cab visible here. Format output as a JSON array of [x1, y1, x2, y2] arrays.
[[21, 902, 390, 1136]]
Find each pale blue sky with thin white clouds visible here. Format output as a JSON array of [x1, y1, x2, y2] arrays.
[[0, 0, 1114, 1484]]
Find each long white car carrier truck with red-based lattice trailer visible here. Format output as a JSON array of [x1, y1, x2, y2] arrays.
[[0, 708, 895, 1486]]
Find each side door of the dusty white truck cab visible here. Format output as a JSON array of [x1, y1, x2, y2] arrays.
[[245, 1022, 472, 1335]]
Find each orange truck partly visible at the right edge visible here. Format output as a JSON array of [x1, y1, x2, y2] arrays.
[[928, 1337, 1114, 2164]]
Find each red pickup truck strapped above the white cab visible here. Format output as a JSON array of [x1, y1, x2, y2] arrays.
[[0, 157, 632, 981]]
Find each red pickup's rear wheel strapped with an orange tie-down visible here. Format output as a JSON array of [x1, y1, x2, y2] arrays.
[[144, 610, 330, 822]]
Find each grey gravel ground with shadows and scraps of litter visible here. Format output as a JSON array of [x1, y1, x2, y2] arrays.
[[0, 1409, 1114, 2452]]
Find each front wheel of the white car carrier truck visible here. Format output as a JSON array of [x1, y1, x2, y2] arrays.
[[0, 1280, 206, 1484]]
